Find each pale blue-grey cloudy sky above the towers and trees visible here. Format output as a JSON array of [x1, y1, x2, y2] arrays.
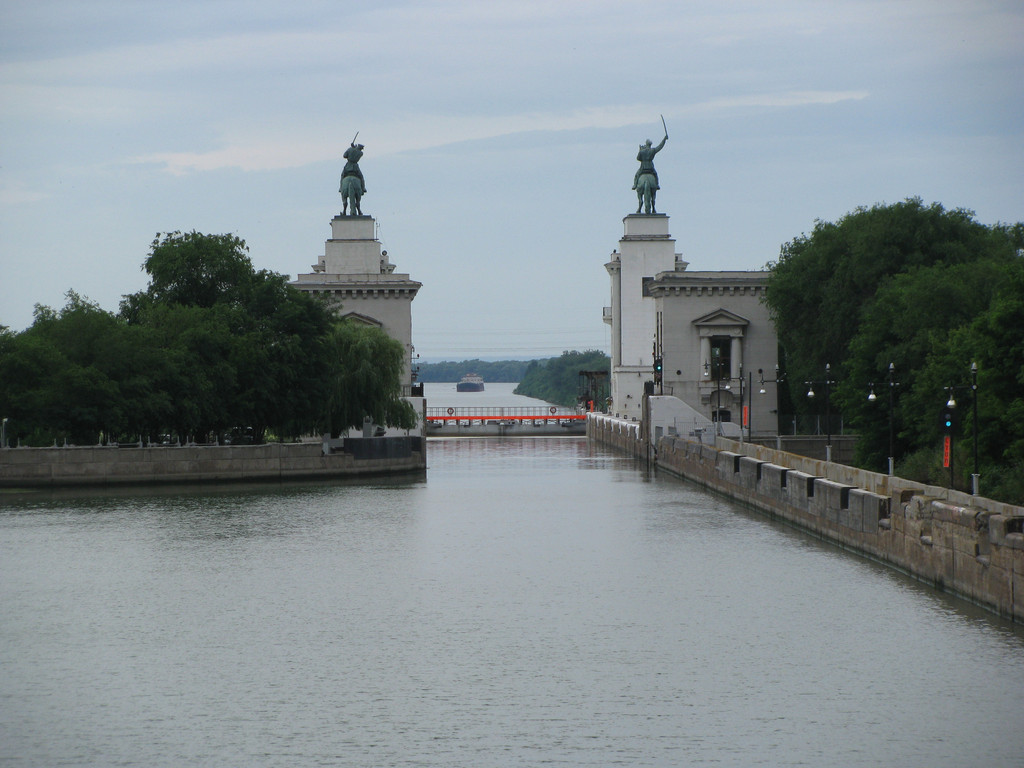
[[0, 0, 1024, 361]]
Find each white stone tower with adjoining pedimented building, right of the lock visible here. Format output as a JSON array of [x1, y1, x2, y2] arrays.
[[604, 214, 778, 437]]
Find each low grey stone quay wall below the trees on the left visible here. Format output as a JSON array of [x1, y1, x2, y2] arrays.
[[0, 437, 426, 487]]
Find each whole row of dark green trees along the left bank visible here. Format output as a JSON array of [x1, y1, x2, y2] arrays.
[[0, 231, 416, 445]]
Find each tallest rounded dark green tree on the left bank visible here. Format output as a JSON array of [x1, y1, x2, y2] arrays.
[[121, 231, 332, 441]]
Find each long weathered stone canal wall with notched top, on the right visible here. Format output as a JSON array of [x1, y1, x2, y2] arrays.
[[588, 419, 1024, 622]]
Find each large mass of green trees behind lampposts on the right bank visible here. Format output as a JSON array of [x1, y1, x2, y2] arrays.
[[766, 199, 1024, 502]]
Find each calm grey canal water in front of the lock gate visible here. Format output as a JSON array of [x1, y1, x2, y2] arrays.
[[0, 393, 1024, 767]]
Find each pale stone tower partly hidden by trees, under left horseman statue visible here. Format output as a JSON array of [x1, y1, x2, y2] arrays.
[[292, 215, 422, 396]]
